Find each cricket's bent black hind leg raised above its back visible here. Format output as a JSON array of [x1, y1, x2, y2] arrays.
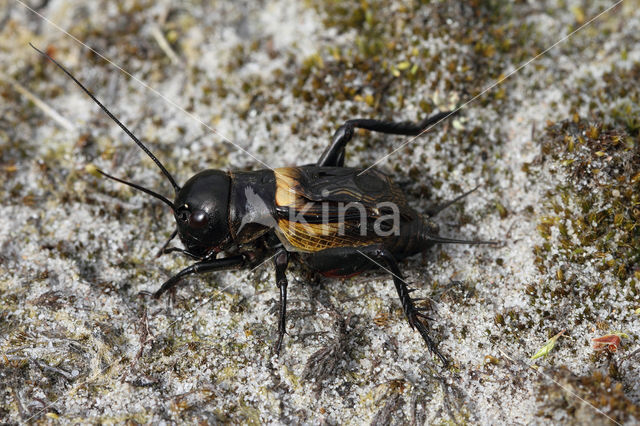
[[316, 111, 457, 167]]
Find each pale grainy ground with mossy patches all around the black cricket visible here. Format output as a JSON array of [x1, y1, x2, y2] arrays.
[[0, 0, 640, 424]]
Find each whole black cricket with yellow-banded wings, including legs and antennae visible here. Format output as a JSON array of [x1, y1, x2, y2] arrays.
[[32, 46, 494, 365]]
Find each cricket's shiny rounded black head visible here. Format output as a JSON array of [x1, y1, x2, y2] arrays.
[[173, 170, 231, 256]]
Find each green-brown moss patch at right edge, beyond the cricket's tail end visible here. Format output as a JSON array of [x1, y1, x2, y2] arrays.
[[538, 117, 640, 283]]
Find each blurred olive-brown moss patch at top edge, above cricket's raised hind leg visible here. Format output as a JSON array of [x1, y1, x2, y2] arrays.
[[292, 0, 541, 131]]
